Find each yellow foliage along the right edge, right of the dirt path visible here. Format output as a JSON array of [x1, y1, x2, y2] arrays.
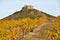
[[48, 16, 60, 40]]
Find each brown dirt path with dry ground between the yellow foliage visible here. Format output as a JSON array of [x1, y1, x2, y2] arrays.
[[23, 22, 54, 40]]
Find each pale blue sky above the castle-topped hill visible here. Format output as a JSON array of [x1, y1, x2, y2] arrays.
[[0, 0, 60, 18]]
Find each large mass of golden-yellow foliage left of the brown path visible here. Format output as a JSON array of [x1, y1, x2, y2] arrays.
[[0, 17, 47, 40]]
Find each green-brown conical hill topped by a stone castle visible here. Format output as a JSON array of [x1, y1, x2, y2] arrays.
[[3, 5, 56, 20]]
